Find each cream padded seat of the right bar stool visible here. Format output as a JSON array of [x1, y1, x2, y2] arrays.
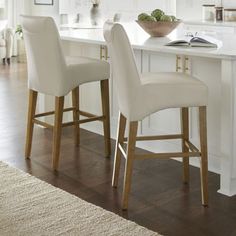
[[124, 72, 208, 121]]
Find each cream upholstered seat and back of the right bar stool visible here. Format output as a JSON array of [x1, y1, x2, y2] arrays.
[[104, 22, 208, 121]]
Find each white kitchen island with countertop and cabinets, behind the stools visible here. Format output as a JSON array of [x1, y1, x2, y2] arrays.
[[54, 23, 236, 196]]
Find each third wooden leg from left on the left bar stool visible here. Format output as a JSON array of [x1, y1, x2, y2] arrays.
[[72, 87, 80, 146]]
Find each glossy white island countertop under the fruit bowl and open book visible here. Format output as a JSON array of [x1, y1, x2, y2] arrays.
[[60, 22, 236, 59]]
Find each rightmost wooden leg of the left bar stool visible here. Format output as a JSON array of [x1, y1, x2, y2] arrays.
[[101, 79, 111, 157]]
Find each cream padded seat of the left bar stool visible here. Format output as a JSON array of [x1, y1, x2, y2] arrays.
[[66, 57, 110, 86]]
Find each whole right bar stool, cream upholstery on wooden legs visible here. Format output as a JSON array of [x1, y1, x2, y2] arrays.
[[104, 22, 208, 209]]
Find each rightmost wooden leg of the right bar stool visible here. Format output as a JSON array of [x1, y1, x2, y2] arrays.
[[199, 106, 208, 206]]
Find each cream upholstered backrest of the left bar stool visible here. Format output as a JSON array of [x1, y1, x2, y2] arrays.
[[21, 16, 66, 96]]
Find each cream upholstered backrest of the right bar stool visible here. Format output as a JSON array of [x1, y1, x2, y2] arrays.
[[104, 21, 140, 116]]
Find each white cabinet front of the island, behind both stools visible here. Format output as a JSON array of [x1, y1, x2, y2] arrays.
[[60, 41, 221, 171]]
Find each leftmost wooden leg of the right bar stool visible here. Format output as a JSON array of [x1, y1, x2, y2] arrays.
[[112, 113, 126, 188]]
